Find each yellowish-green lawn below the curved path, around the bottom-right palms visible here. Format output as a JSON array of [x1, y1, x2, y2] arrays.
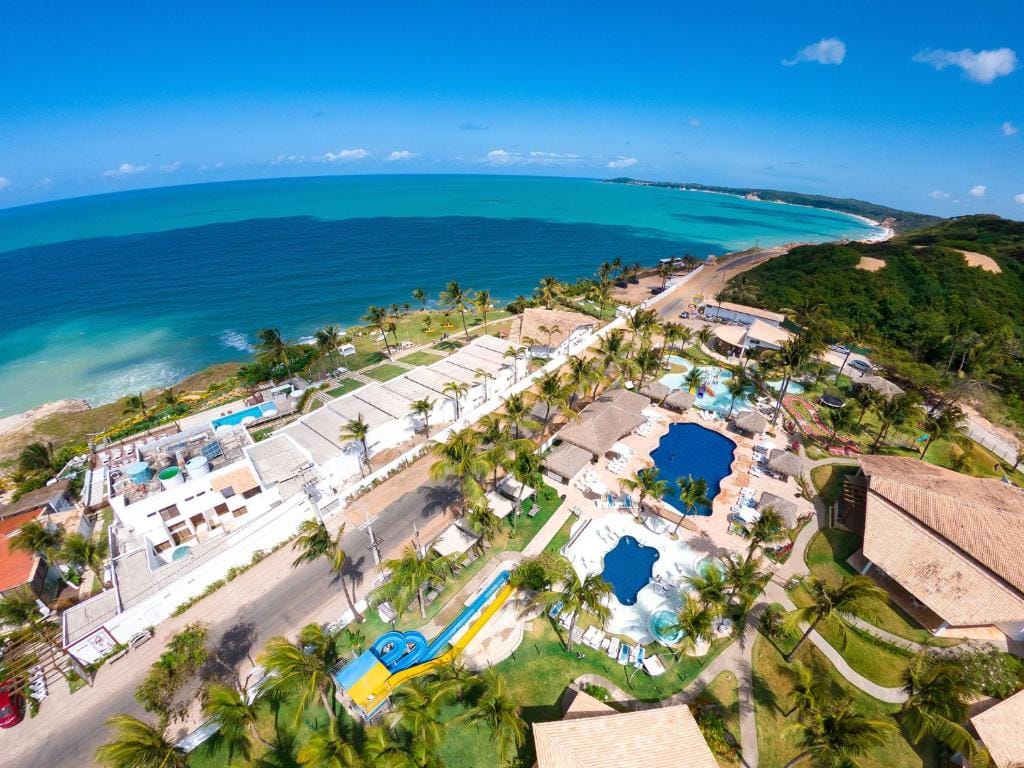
[[754, 636, 939, 768]]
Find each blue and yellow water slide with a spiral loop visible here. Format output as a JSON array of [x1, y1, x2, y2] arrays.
[[347, 570, 515, 713]]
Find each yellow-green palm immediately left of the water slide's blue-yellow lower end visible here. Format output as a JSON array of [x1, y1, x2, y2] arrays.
[[260, 624, 342, 727]]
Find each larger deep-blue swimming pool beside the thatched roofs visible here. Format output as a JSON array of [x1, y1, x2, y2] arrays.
[[650, 424, 736, 515]]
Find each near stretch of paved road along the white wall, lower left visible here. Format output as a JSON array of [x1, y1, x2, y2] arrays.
[[8, 483, 457, 768]]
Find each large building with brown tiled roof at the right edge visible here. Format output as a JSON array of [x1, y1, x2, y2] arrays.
[[844, 456, 1024, 640]]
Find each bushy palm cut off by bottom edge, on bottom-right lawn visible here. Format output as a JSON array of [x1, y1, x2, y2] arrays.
[[783, 697, 893, 768]]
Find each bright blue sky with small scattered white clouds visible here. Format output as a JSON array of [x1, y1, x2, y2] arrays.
[[0, 0, 1024, 218]]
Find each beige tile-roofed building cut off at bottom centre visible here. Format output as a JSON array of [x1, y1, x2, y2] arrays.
[[532, 688, 718, 768]]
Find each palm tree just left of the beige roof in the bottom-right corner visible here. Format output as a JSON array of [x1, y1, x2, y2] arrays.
[[897, 651, 981, 758]]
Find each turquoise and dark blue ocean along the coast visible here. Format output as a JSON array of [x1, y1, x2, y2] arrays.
[[0, 175, 878, 417]]
